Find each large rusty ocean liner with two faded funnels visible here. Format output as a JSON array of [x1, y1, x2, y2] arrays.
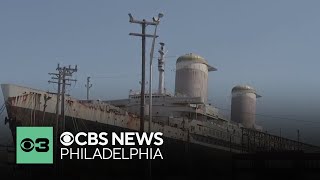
[[1, 50, 319, 175]]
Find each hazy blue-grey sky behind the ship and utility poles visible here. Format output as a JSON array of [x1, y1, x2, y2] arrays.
[[0, 0, 320, 146]]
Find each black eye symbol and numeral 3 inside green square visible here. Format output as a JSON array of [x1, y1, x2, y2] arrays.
[[20, 138, 49, 152]]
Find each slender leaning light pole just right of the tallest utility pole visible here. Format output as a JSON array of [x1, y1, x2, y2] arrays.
[[148, 13, 163, 133]]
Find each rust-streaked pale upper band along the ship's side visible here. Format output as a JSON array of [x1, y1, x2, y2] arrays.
[[2, 85, 319, 152]]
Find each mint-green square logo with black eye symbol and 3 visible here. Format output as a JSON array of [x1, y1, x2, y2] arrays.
[[16, 127, 53, 164]]
